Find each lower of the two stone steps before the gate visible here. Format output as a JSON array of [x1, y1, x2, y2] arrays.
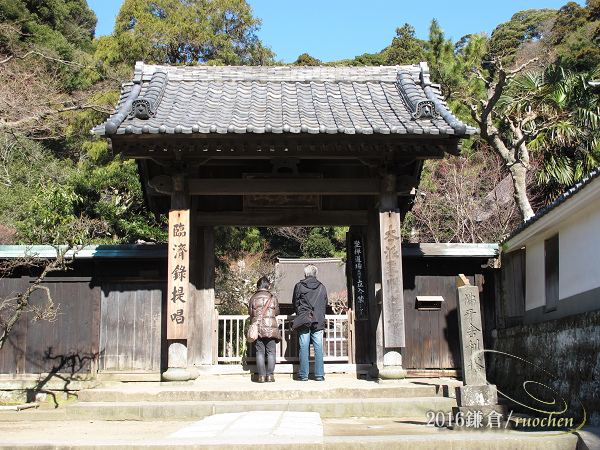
[[66, 396, 456, 420]]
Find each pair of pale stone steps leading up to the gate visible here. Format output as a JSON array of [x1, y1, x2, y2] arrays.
[[67, 375, 462, 420]]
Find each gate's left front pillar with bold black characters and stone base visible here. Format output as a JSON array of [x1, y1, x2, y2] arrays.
[[163, 173, 192, 381]]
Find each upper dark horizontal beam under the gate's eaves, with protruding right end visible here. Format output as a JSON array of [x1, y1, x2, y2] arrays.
[[189, 178, 418, 195]]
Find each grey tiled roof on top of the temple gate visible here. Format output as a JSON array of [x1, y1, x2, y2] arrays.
[[92, 63, 477, 137]]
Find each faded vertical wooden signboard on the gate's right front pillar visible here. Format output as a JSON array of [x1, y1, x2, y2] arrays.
[[379, 211, 406, 348]]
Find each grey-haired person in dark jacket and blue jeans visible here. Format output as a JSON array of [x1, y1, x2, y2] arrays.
[[292, 264, 328, 381]]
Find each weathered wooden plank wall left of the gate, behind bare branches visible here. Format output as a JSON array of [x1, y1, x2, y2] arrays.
[[0, 259, 166, 374]]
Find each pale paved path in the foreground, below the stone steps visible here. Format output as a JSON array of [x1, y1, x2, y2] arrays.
[[0, 411, 584, 450]]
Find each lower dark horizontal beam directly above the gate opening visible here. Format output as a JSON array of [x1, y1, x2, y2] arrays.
[[196, 210, 368, 227]]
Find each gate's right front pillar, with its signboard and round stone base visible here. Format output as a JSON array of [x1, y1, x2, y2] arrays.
[[379, 174, 406, 380]]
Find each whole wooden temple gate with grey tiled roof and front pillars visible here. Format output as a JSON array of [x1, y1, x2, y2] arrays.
[[93, 63, 477, 380]]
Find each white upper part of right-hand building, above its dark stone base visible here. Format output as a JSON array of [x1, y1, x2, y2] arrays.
[[503, 165, 600, 324]]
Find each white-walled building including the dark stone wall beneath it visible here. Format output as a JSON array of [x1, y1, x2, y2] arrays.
[[489, 168, 600, 426]]
